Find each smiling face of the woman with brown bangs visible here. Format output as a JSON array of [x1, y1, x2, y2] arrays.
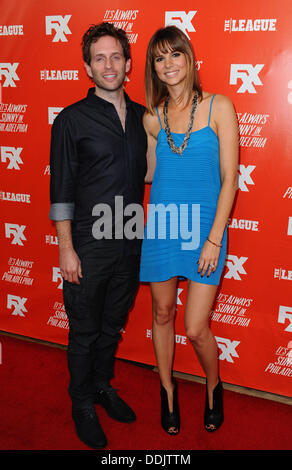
[[154, 49, 187, 86]]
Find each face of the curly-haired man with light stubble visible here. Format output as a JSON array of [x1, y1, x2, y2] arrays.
[[84, 36, 131, 92]]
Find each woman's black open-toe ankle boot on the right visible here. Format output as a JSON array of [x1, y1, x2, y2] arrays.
[[204, 378, 223, 432]]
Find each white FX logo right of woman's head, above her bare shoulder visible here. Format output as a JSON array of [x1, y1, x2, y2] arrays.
[[229, 64, 264, 93]]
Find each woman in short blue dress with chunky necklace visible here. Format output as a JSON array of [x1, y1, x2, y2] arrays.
[[140, 26, 238, 435]]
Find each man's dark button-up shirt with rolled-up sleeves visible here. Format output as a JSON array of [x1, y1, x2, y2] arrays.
[[49, 88, 147, 254]]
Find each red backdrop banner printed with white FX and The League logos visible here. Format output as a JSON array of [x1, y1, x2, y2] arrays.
[[0, 0, 292, 396]]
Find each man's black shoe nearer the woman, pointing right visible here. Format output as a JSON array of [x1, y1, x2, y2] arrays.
[[95, 388, 136, 423]]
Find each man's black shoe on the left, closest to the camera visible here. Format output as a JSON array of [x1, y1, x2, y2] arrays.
[[72, 406, 107, 449]]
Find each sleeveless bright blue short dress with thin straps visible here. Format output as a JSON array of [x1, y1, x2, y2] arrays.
[[140, 96, 227, 285]]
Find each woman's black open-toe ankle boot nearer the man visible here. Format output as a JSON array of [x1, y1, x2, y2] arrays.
[[160, 382, 180, 436]]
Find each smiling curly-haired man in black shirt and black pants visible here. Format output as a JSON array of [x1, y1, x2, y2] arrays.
[[50, 23, 147, 448]]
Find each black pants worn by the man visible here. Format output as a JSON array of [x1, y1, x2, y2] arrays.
[[63, 247, 140, 406]]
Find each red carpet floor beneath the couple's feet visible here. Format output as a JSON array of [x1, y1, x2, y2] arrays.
[[0, 335, 292, 451]]
